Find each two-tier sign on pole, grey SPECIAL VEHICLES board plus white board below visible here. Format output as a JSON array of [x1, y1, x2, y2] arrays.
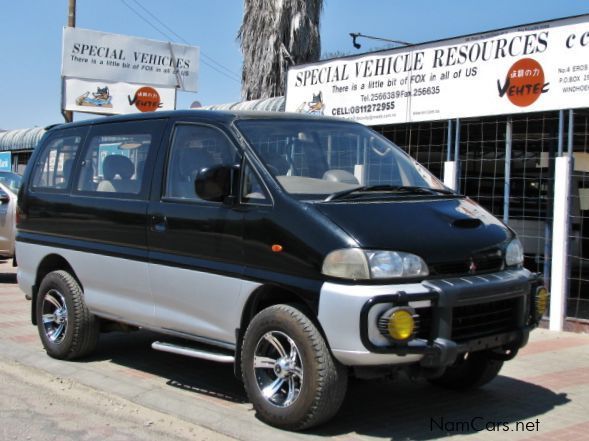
[[61, 28, 199, 115]]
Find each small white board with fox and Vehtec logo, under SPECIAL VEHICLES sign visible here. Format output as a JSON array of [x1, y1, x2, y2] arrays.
[[63, 78, 176, 115]]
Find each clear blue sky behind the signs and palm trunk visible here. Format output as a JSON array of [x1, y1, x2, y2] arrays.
[[0, 0, 589, 130]]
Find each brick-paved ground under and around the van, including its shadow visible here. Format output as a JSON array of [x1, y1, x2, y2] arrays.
[[0, 263, 589, 440]]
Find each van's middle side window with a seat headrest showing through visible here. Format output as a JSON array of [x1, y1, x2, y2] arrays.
[[76, 121, 161, 197]]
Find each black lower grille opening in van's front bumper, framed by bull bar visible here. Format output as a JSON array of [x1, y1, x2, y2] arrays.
[[452, 298, 519, 342]]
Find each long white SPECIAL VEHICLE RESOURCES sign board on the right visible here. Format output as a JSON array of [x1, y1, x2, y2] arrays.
[[286, 15, 589, 125]]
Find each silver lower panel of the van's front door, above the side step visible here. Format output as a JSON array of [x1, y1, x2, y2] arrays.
[[149, 264, 260, 343]]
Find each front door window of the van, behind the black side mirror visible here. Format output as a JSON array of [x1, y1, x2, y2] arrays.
[[164, 124, 239, 200]]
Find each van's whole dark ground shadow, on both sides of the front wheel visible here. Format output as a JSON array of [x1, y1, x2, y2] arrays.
[[85, 331, 569, 440]]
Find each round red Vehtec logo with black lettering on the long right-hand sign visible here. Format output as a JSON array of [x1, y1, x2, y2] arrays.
[[497, 58, 550, 107]]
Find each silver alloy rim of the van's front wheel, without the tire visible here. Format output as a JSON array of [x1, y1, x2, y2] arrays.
[[254, 331, 303, 408]]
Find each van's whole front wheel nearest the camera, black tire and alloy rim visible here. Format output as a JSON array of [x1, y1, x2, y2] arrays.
[[241, 305, 347, 430]]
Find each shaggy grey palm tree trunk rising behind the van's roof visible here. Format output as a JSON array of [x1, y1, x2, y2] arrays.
[[237, 0, 323, 100]]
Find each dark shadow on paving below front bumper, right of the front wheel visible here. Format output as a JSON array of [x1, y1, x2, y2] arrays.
[[314, 376, 569, 440]]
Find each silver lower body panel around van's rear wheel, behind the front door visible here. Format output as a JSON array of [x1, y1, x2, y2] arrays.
[[17, 242, 154, 326]]
